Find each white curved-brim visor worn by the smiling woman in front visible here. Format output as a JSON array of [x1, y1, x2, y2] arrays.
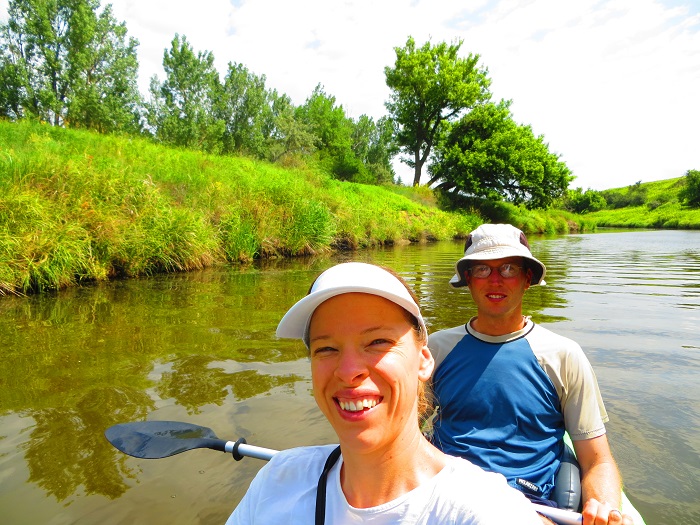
[[277, 262, 428, 347]]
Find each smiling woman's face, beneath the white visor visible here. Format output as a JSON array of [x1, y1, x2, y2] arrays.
[[309, 293, 434, 453]]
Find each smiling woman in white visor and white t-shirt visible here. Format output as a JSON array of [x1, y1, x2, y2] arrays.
[[227, 262, 541, 525]]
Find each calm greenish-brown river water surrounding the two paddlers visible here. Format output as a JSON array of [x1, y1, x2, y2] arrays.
[[0, 231, 700, 525]]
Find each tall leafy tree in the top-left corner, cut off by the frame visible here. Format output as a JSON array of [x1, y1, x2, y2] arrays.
[[0, 0, 141, 131]]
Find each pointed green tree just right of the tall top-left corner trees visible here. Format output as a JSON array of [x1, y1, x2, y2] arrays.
[[146, 34, 225, 152]]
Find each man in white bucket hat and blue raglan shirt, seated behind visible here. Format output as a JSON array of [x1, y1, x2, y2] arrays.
[[429, 224, 628, 523]]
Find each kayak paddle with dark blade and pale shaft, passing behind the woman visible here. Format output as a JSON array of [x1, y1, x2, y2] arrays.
[[105, 421, 583, 525]]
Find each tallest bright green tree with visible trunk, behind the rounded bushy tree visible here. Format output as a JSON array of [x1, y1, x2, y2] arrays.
[[384, 37, 490, 186]]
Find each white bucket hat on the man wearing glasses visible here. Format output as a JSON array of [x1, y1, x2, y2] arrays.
[[450, 224, 547, 288]]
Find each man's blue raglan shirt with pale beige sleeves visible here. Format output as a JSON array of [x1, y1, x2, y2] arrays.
[[428, 318, 608, 498]]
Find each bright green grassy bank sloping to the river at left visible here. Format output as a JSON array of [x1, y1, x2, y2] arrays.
[[0, 122, 481, 295]]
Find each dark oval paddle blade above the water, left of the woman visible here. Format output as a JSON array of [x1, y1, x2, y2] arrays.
[[105, 421, 226, 459]]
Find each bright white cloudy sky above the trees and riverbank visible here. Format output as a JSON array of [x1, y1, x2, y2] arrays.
[[0, 0, 700, 190]]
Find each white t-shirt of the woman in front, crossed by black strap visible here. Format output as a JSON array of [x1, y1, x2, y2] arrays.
[[226, 445, 542, 525]]
